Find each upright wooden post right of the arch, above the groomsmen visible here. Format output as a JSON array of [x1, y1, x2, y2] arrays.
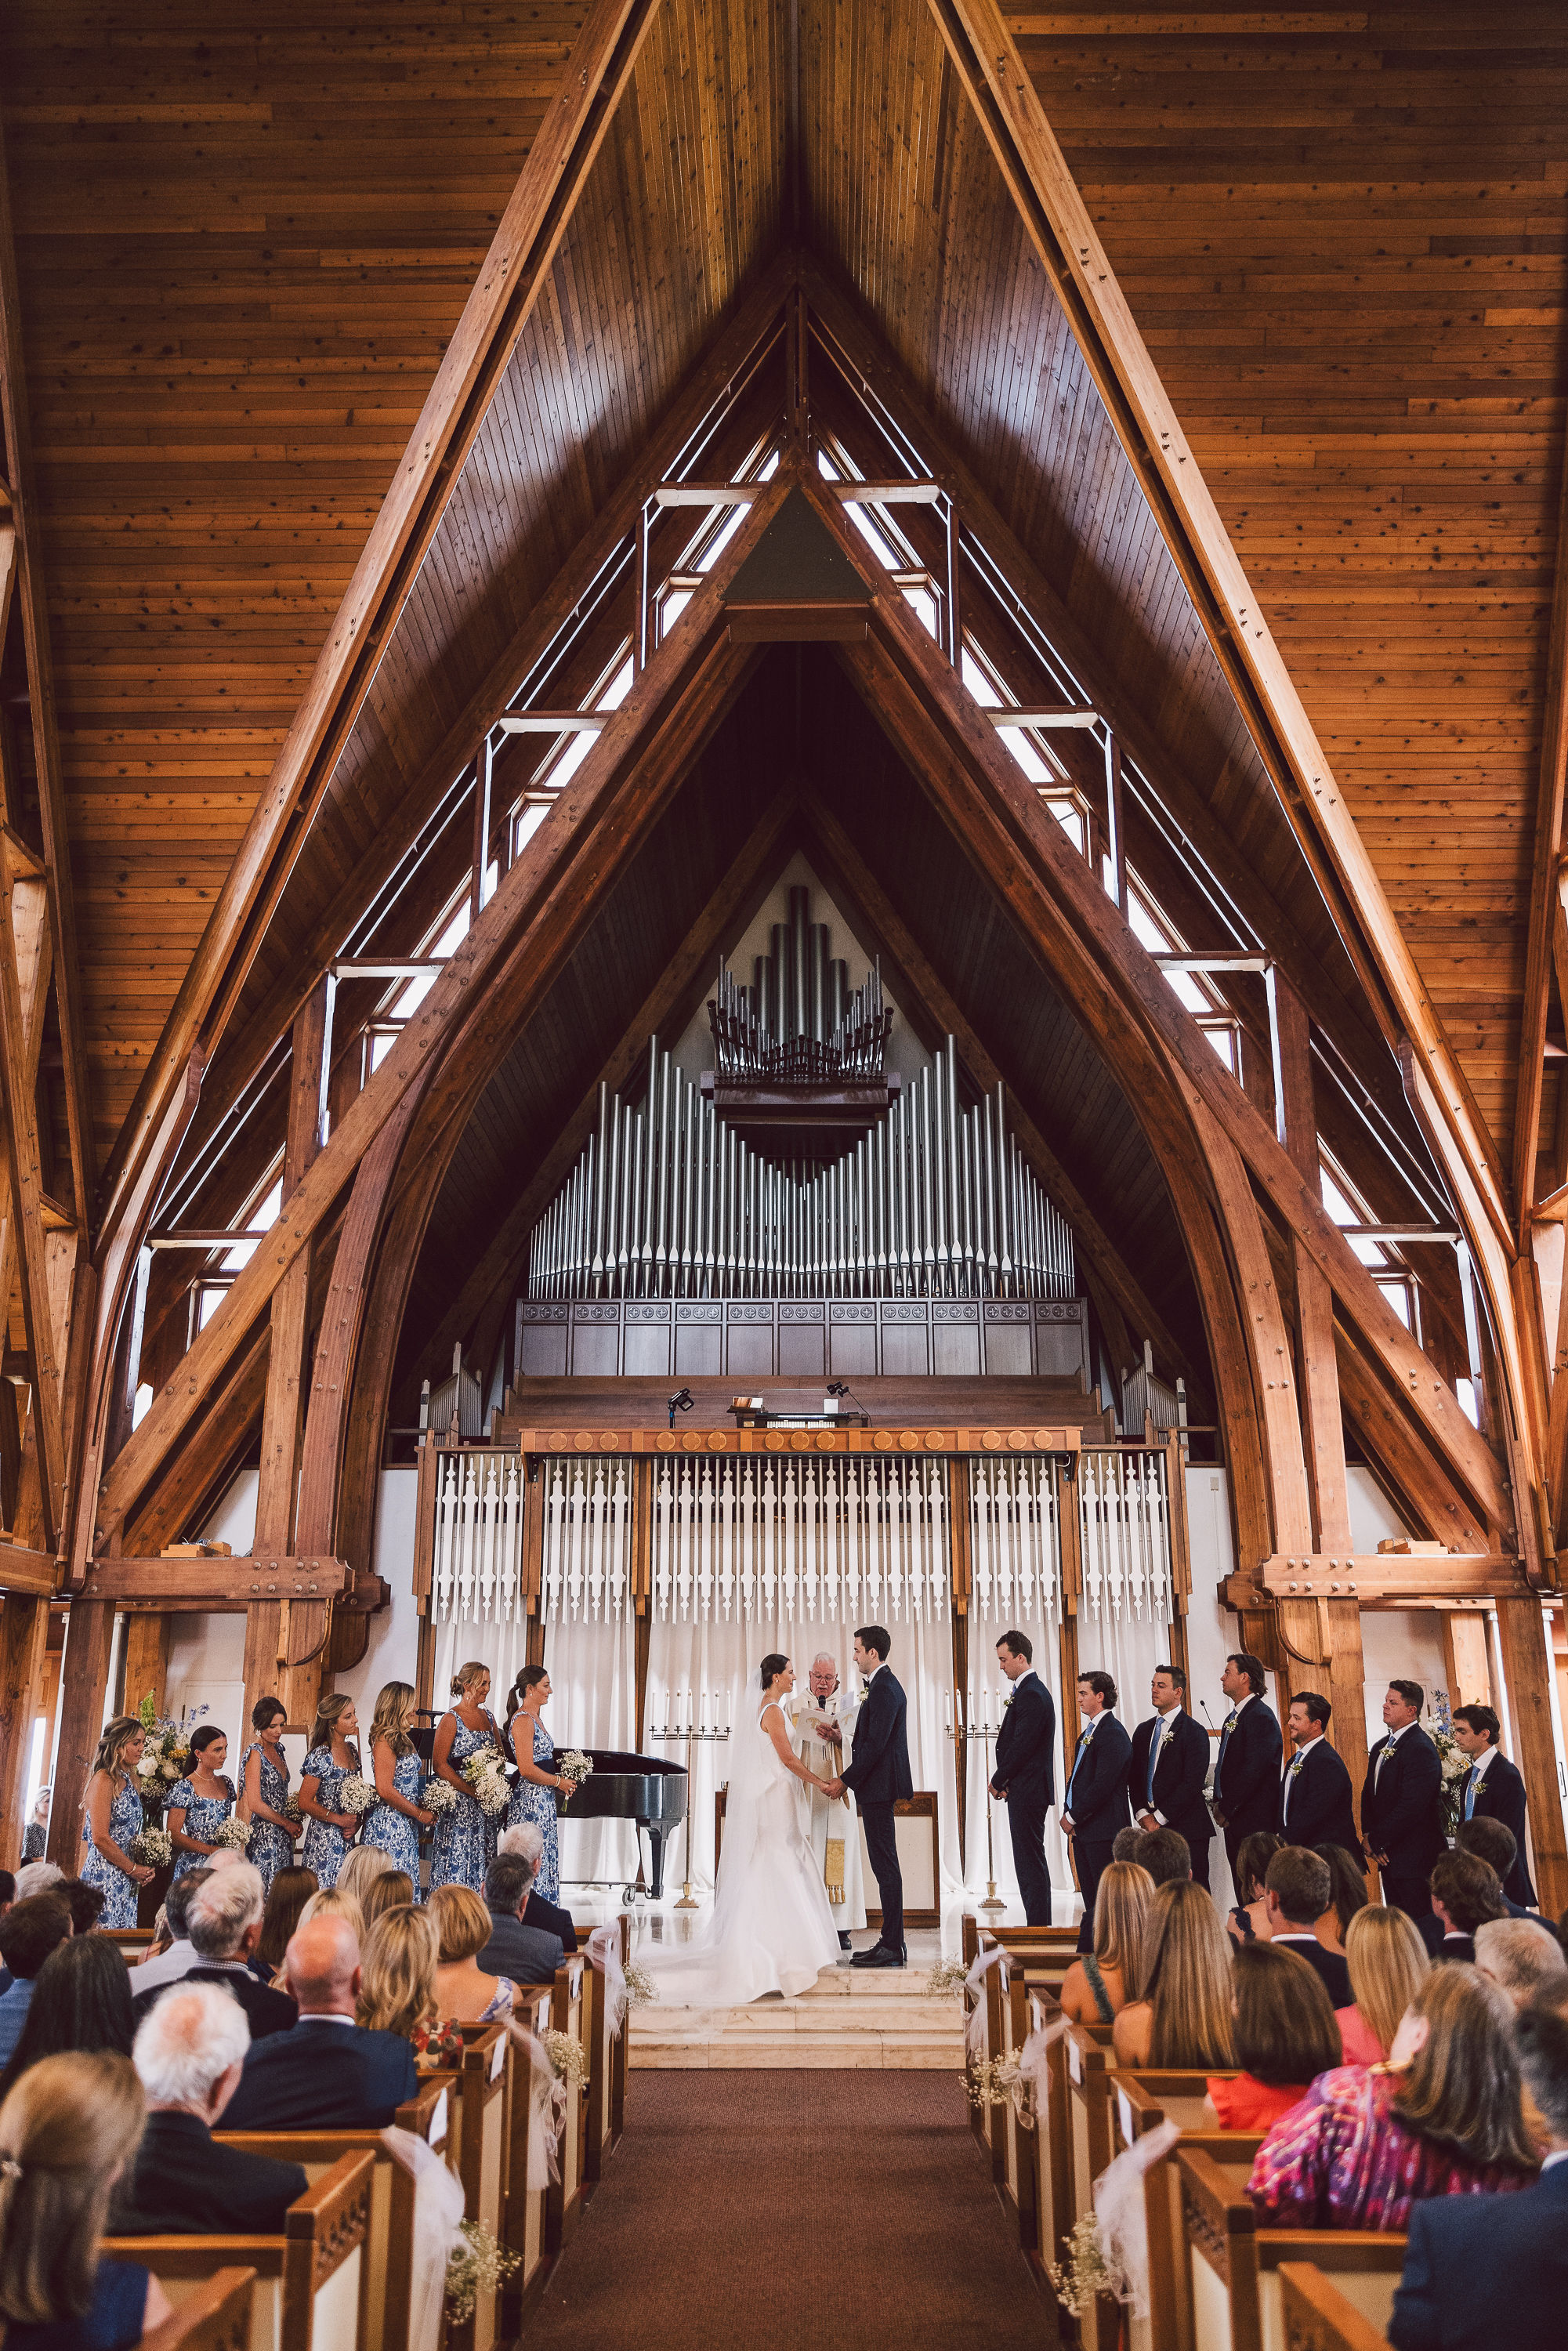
[[1267, 966, 1349, 1554]]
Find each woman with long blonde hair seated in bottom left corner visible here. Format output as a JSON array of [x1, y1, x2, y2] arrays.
[[0, 2050, 172, 2351]]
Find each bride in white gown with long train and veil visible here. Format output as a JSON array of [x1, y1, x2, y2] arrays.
[[637, 1655, 839, 2008]]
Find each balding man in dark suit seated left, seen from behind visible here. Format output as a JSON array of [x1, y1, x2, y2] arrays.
[[226, 1895, 421, 2130]]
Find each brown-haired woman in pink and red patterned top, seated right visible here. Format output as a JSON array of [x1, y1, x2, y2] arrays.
[[1246, 1968, 1535, 2231]]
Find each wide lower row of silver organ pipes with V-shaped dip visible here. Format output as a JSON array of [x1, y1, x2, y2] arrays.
[[529, 1037, 1077, 1298]]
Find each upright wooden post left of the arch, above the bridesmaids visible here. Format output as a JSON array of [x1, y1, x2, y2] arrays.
[[244, 978, 334, 1730]]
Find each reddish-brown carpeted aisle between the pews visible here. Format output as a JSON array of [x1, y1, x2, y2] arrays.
[[524, 2071, 1053, 2351]]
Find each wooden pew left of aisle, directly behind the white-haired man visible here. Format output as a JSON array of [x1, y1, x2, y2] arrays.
[[103, 2154, 376, 2351]]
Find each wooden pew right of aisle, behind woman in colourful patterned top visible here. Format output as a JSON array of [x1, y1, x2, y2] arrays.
[[1178, 2149, 1406, 2351]]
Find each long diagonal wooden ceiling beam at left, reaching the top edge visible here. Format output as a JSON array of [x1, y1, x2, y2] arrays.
[[93, 0, 656, 1270]]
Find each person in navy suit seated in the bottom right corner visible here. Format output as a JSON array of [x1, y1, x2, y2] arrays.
[[1389, 1987, 1568, 2351]]
